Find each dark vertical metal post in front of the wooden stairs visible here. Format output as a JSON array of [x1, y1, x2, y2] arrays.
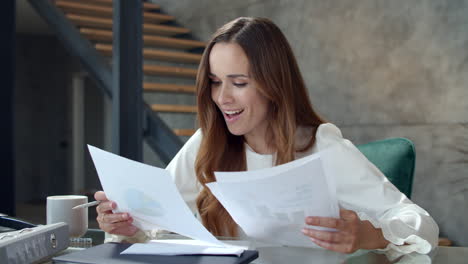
[[112, 0, 143, 161]]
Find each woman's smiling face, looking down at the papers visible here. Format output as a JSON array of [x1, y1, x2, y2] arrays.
[[209, 43, 268, 143]]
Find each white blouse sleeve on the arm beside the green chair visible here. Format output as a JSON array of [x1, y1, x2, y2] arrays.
[[316, 124, 439, 254]]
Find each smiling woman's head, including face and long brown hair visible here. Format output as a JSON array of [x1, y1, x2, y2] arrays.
[[195, 18, 323, 235]]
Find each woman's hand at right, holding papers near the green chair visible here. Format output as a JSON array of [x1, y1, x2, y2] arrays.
[[302, 209, 389, 254]]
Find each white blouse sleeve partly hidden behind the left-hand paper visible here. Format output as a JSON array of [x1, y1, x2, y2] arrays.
[[105, 129, 202, 243]]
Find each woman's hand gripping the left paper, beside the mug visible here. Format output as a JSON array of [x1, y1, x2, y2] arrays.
[[94, 191, 138, 236]]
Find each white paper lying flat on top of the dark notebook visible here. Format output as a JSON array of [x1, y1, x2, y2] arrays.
[[121, 239, 248, 256]]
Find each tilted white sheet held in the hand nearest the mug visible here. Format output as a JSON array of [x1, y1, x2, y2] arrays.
[[88, 145, 226, 247]]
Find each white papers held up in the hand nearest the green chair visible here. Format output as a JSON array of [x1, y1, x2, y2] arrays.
[[207, 151, 339, 247]]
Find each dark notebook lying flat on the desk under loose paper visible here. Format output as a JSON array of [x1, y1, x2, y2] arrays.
[[53, 243, 258, 264]]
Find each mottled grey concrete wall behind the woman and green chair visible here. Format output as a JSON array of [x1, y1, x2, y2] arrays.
[[155, 0, 468, 246]]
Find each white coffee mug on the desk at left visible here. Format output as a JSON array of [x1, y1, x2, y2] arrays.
[[47, 195, 88, 237]]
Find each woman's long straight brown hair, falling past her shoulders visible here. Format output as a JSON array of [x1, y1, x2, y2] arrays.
[[195, 17, 324, 236]]
